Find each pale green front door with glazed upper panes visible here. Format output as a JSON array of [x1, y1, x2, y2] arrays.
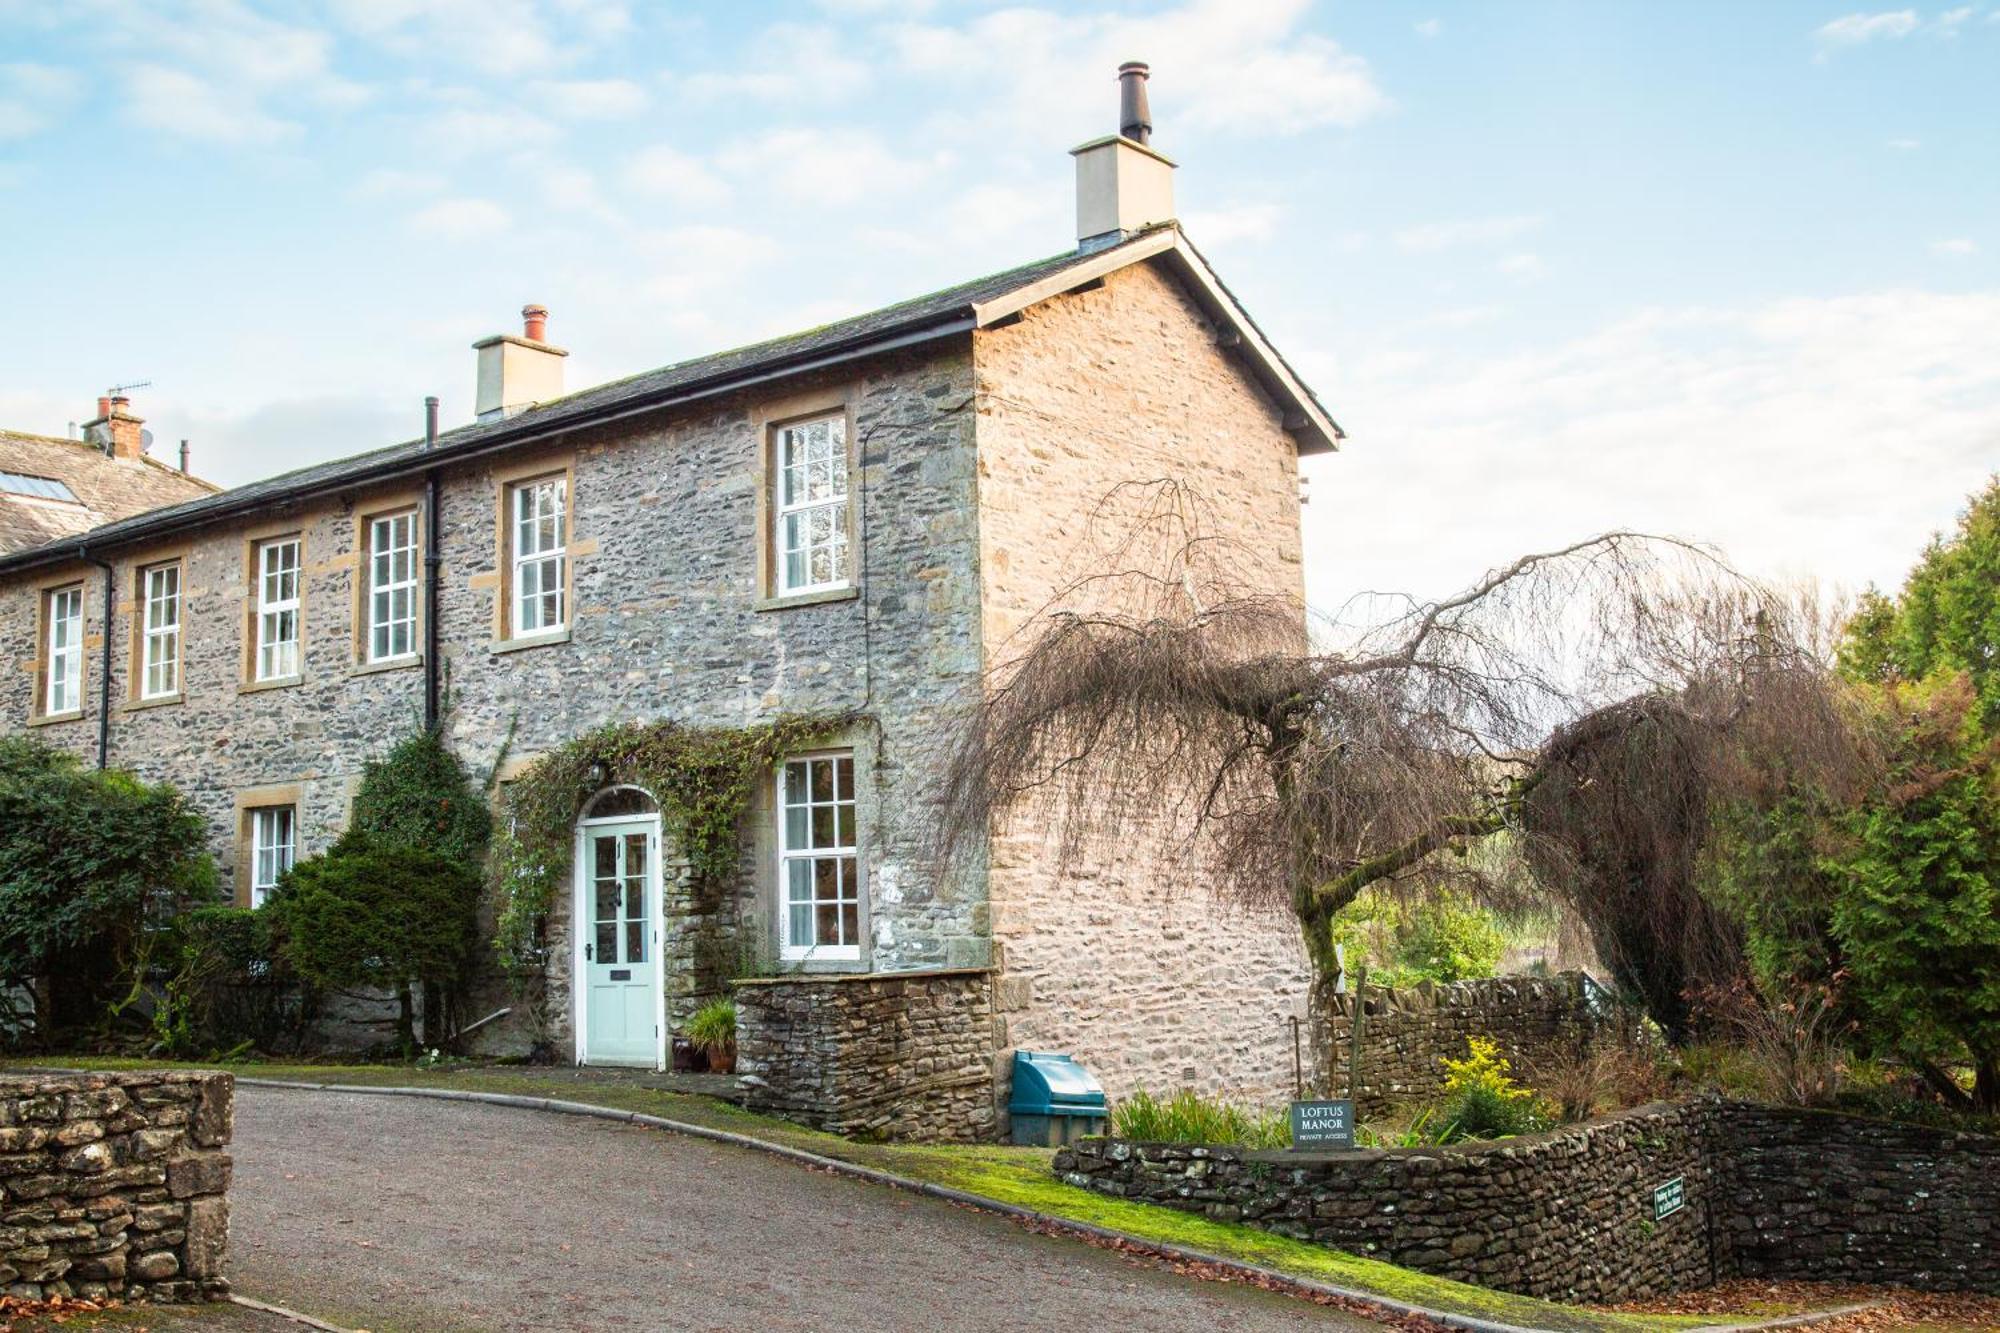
[[578, 821, 662, 1069]]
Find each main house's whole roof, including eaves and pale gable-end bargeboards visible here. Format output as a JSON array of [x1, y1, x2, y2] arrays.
[[0, 224, 1340, 570]]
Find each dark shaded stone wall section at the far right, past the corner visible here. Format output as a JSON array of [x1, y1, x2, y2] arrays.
[[1716, 1107, 2000, 1293]]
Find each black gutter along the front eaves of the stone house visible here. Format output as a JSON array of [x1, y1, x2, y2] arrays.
[[0, 314, 976, 574]]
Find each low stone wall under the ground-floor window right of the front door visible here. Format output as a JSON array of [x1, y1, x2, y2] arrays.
[[734, 969, 996, 1143]]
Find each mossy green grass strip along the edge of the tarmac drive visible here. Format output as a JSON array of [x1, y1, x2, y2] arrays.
[[19, 1057, 1752, 1333]]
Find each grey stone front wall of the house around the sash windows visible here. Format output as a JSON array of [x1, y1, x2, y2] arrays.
[[0, 348, 988, 1055]]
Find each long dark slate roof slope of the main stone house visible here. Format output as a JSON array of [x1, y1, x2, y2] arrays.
[[0, 222, 1338, 572]]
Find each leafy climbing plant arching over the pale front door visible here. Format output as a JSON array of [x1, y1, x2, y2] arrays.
[[490, 713, 854, 989]]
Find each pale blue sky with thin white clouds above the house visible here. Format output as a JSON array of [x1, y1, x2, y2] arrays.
[[0, 0, 2000, 606]]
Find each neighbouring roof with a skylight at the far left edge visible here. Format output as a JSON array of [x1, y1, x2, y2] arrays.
[[0, 430, 216, 560]]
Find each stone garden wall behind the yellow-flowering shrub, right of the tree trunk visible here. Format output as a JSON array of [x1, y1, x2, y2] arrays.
[[1320, 973, 1594, 1119]]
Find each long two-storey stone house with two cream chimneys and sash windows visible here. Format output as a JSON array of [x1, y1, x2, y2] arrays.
[[0, 70, 1338, 1137]]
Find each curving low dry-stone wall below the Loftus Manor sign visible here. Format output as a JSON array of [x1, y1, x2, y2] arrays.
[[1056, 1105, 1714, 1301]]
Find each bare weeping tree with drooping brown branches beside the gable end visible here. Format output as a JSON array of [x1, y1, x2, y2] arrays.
[[940, 480, 1864, 1031]]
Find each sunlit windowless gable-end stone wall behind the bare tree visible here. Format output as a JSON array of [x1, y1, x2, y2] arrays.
[[974, 262, 1314, 1101]]
